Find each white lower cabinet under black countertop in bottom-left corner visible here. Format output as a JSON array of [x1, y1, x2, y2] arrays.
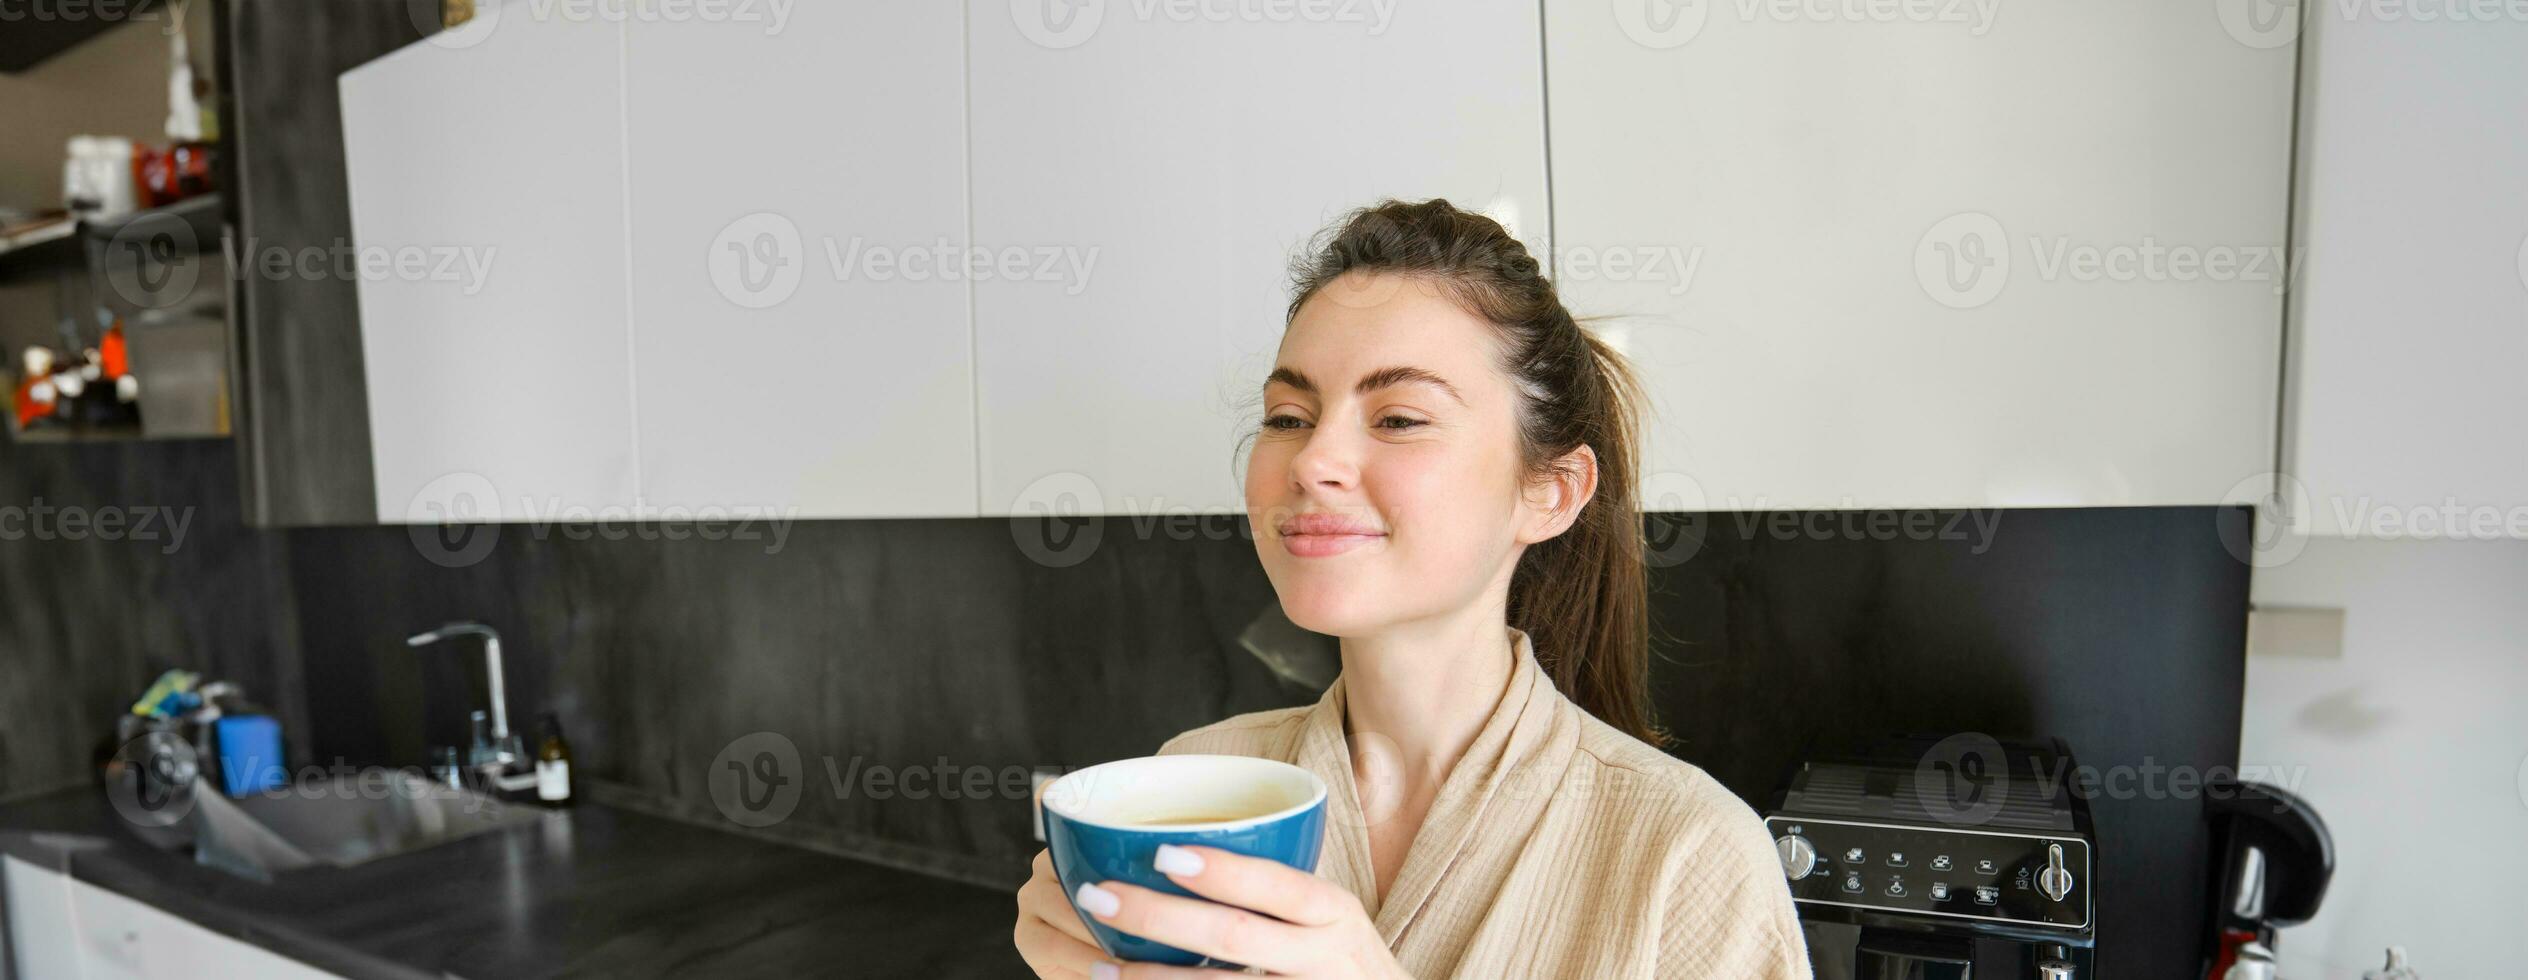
[[5, 859, 334, 980]]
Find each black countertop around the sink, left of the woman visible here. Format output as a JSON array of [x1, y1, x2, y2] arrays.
[[0, 788, 1029, 980]]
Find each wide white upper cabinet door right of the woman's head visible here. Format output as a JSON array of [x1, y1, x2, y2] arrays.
[[1545, 0, 2305, 510]]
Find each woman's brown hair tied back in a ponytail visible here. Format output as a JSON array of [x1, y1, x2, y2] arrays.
[[1284, 197, 1666, 748]]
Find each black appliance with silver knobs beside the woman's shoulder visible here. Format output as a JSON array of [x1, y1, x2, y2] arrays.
[[1765, 732, 2098, 980]]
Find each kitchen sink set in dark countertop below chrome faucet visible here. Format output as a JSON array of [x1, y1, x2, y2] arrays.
[[158, 770, 549, 881]]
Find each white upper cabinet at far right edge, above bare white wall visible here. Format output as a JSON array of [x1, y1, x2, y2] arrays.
[[2285, 8, 2528, 538]]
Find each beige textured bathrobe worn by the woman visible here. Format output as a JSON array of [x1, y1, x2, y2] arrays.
[[1160, 629, 1810, 980]]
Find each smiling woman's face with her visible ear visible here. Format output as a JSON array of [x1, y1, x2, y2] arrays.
[[1246, 273, 1585, 636]]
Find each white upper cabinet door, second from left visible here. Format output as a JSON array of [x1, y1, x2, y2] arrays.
[[624, 0, 976, 518]]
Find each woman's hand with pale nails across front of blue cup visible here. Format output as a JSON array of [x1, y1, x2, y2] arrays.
[[1056, 844, 1411, 980]]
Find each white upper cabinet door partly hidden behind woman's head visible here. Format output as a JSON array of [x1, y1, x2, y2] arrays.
[[966, 0, 1547, 515]]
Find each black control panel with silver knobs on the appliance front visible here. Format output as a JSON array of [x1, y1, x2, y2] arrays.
[[1765, 816, 2091, 929]]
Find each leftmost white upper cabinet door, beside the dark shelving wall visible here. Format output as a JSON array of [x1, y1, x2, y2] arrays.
[[341, 0, 637, 523]]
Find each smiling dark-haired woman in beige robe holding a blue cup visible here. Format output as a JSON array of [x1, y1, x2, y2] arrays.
[[1016, 200, 1808, 980]]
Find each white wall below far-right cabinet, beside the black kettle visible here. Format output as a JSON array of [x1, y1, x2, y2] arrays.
[[2240, 538, 2528, 980]]
